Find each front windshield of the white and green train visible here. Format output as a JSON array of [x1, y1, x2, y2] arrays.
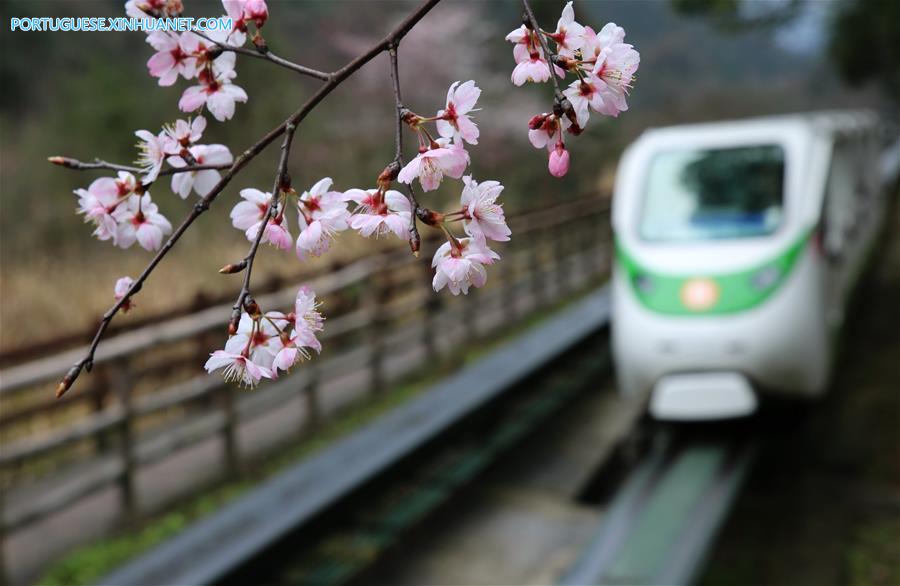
[[640, 145, 784, 242]]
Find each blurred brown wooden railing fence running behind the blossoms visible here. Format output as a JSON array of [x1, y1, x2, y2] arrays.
[[0, 198, 609, 576]]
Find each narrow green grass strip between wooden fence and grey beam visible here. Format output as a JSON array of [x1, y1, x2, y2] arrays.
[[38, 283, 596, 586]]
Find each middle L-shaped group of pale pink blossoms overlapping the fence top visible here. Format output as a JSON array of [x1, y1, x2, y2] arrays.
[[225, 81, 510, 295]]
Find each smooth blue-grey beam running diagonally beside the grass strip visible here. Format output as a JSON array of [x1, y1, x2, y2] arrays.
[[100, 289, 609, 586]]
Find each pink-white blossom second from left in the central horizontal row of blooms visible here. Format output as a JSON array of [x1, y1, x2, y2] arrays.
[[295, 177, 350, 259]]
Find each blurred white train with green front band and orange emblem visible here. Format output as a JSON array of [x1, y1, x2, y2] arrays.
[[612, 112, 896, 420]]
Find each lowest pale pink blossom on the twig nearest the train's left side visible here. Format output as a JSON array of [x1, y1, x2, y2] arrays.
[[431, 238, 500, 295]]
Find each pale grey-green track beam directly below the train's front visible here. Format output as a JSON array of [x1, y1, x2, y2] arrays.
[[559, 430, 758, 586]]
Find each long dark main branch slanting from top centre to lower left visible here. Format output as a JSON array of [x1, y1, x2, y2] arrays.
[[56, 0, 440, 398]]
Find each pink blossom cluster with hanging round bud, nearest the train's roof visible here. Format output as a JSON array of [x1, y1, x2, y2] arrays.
[[506, 2, 640, 177]]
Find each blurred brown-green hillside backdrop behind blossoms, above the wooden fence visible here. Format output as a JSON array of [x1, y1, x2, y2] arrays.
[[0, 0, 880, 349]]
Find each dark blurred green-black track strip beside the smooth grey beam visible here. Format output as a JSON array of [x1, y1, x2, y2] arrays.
[[225, 336, 608, 586]]
